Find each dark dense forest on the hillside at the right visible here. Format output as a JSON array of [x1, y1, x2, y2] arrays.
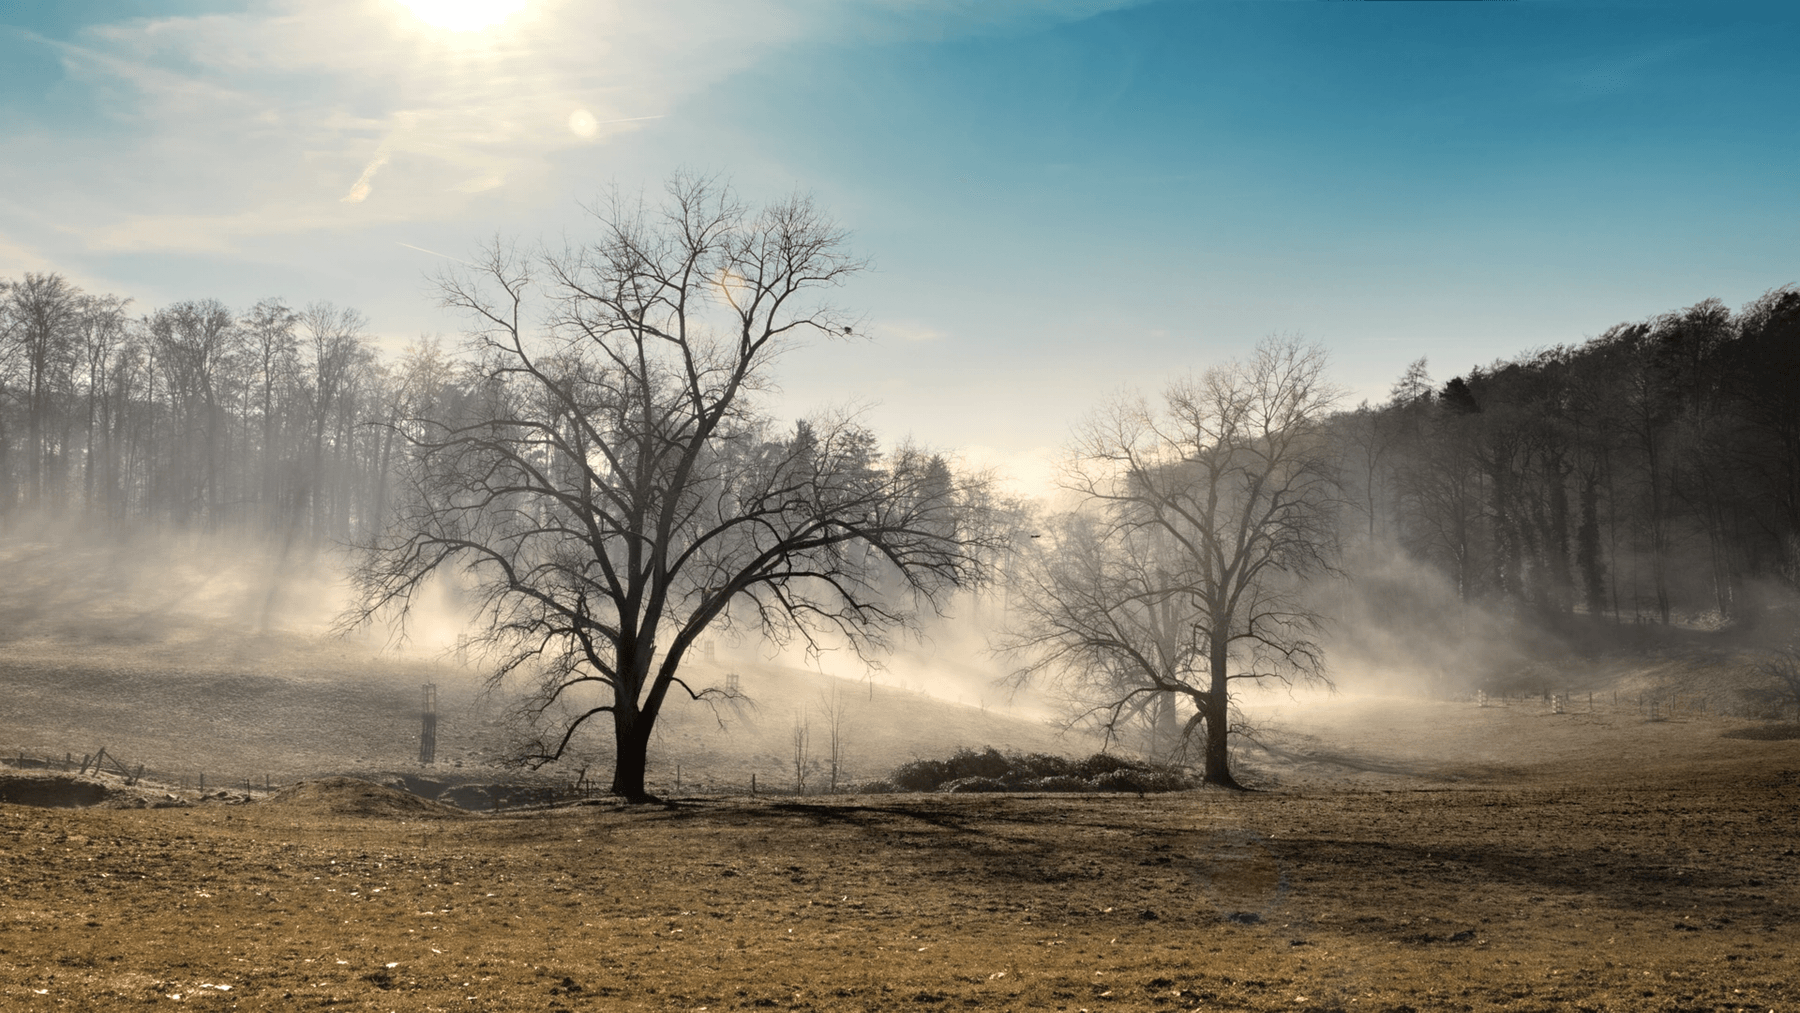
[[1334, 286, 1800, 624]]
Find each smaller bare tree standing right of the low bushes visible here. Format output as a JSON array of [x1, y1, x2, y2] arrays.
[[1010, 338, 1339, 788]]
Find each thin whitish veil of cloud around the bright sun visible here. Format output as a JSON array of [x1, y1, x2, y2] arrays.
[[0, 0, 1144, 261]]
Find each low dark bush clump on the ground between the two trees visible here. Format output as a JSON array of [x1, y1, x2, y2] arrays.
[[884, 747, 1192, 793]]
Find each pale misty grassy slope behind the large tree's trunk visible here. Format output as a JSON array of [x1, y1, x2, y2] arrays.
[[0, 540, 1098, 790]]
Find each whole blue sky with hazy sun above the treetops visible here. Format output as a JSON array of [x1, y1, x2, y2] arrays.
[[0, 0, 1800, 493]]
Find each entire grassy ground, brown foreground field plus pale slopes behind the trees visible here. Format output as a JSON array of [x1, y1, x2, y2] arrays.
[[0, 540, 1800, 1013]]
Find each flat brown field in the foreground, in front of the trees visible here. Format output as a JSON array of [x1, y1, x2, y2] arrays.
[[0, 700, 1800, 1013]]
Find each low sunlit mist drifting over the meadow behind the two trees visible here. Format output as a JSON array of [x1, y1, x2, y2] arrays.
[[0, 503, 1778, 784]]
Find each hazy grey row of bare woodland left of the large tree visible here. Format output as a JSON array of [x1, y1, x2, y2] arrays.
[[0, 273, 450, 542]]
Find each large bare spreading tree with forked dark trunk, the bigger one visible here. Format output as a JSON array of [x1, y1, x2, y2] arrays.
[[347, 176, 979, 801]]
